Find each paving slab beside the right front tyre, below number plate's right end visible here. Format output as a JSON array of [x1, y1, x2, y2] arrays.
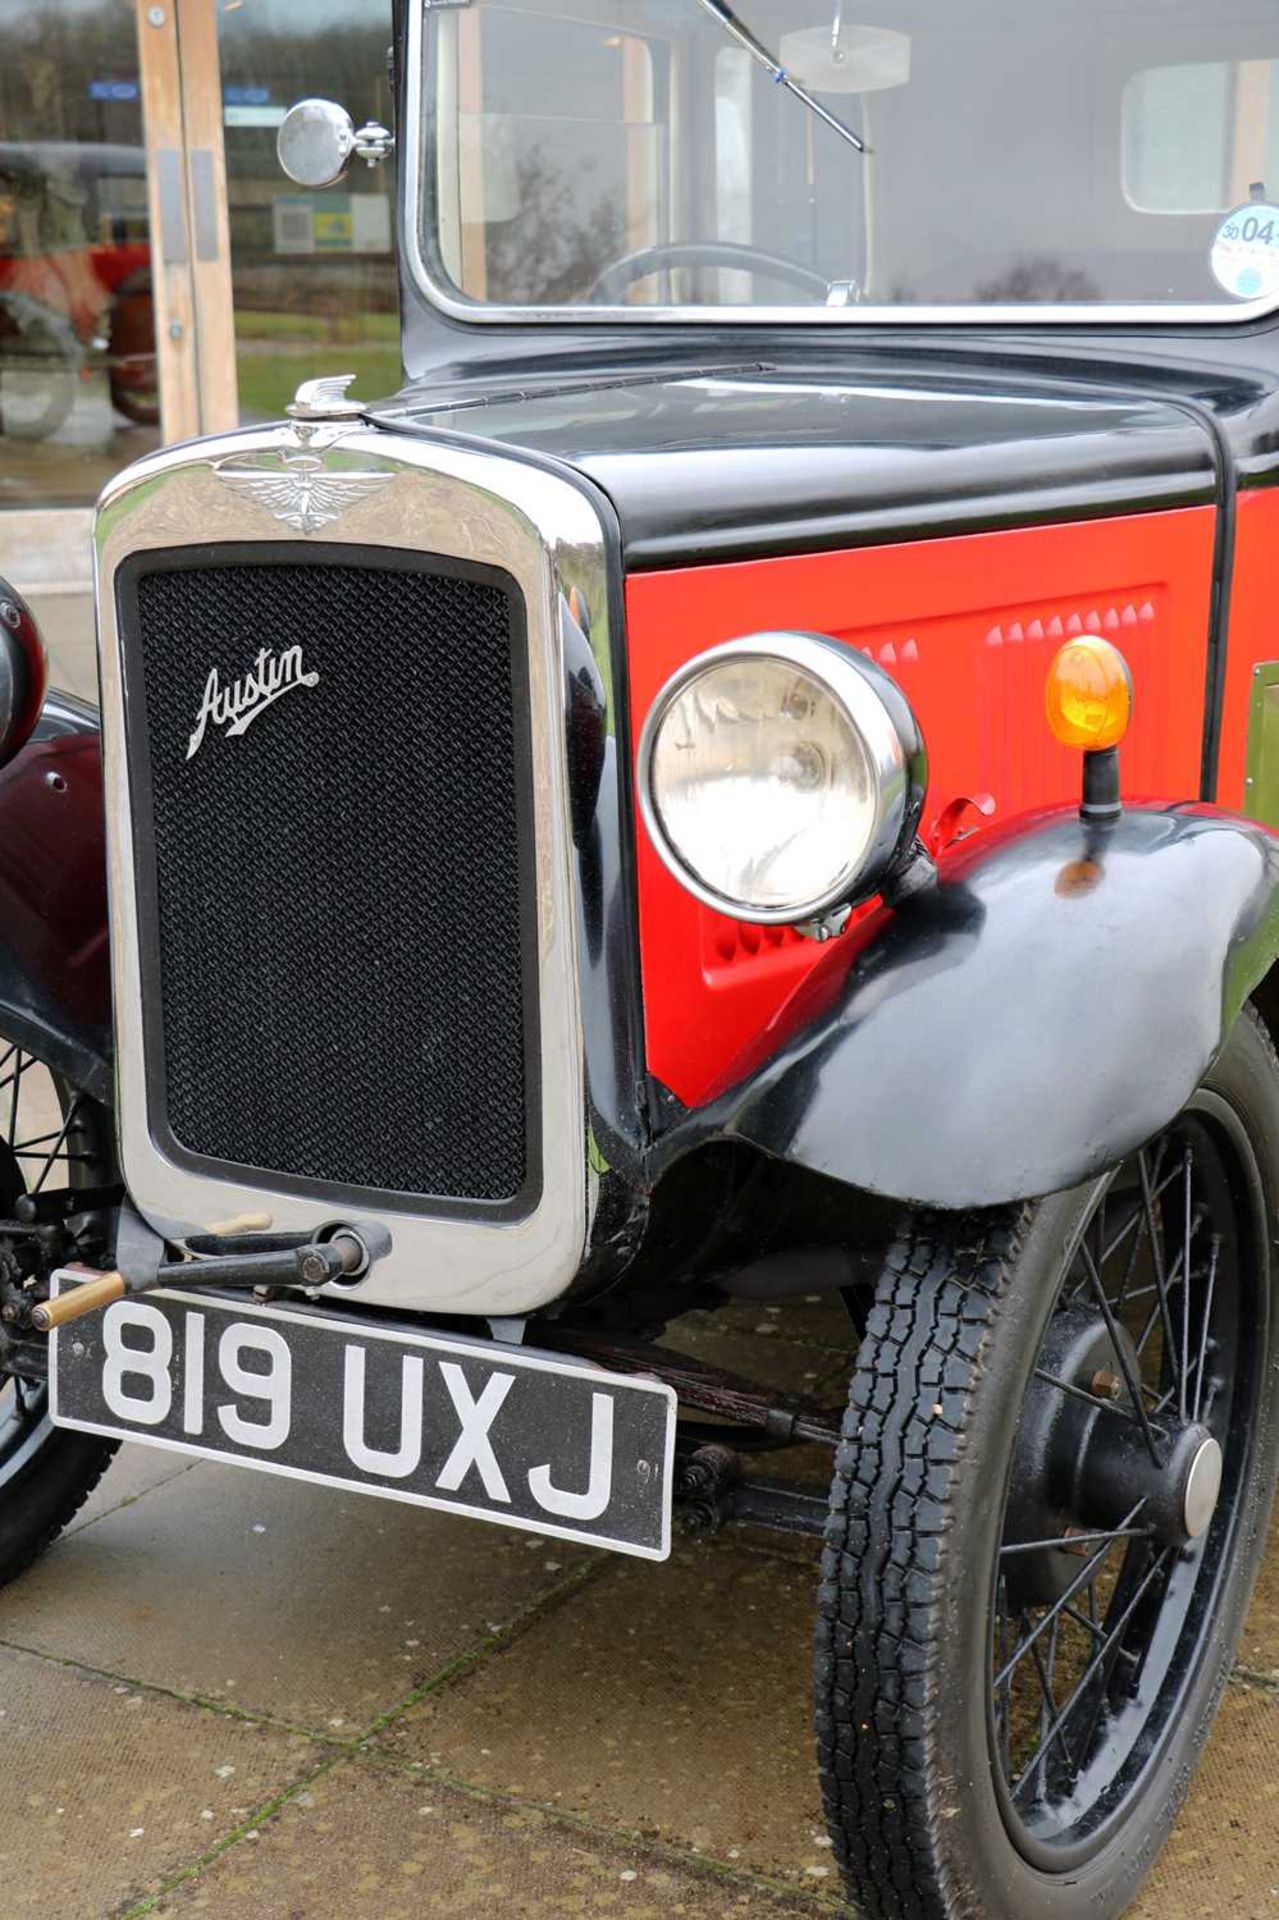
[[370, 1540, 830, 1885]]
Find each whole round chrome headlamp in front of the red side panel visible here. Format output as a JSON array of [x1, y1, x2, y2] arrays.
[[640, 634, 926, 924]]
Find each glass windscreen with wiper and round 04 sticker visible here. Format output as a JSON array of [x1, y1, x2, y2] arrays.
[[417, 0, 1279, 319]]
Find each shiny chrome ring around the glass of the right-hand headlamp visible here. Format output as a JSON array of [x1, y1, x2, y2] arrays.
[[636, 632, 924, 927]]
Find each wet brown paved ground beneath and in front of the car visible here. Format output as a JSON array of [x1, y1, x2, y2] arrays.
[[0, 1308, 1279, 1920]]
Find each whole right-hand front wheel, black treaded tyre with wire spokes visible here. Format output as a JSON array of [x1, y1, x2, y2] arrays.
[[816, 1010, 1279, 1920]]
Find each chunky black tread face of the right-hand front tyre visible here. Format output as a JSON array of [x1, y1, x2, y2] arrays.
[[816, 1208, 1026, 1920]]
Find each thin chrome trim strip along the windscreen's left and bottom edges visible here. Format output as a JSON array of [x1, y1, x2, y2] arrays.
[[399, 0, 1279, 330]]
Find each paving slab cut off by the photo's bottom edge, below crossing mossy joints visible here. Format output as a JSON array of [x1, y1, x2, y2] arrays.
[[156, 1764, 810, 1920]]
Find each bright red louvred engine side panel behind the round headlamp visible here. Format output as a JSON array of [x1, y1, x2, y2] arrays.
[[626, 510, 1213, 1106]]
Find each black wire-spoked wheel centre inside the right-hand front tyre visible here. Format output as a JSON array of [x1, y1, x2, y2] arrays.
[[989, 1108, 1264, 1866]]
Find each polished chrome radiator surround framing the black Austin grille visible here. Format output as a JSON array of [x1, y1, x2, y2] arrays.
[[94, 422, 609, 1317]]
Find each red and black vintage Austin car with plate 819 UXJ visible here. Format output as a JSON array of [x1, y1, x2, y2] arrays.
[[0, 0, 1279, 1920]]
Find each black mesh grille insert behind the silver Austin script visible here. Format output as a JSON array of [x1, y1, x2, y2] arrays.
[[121, 553, 532, 1202]]
